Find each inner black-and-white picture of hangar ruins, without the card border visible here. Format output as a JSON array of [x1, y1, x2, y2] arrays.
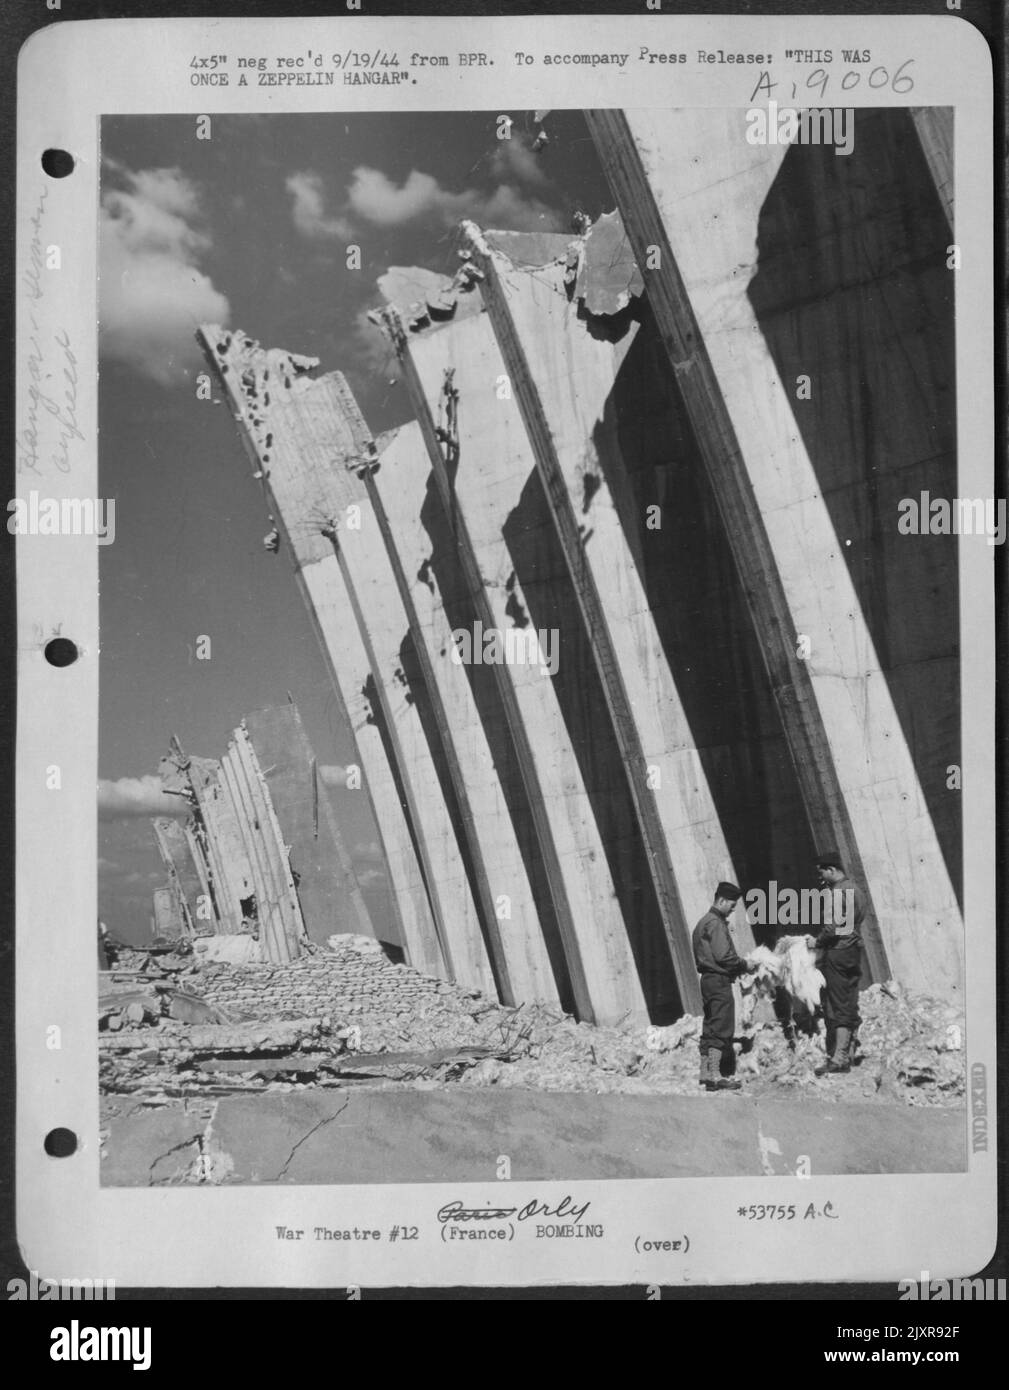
[[97, 100, 972, 1184]]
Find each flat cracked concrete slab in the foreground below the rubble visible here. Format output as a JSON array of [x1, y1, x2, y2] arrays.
[[101, 1087, 966, 1187]]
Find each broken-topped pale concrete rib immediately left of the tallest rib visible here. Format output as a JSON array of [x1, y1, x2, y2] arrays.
[[473, 214, 752, 984]]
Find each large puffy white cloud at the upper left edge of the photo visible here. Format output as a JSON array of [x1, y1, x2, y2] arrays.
[[100, 160, 231, 386]]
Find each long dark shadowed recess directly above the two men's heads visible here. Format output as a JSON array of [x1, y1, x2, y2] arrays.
[[597, 306, 816, 942]]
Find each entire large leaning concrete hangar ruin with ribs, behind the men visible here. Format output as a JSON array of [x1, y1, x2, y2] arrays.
[[199, 110, 963, 1023]]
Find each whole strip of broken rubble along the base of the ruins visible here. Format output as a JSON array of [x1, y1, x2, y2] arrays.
[[100, 935, 965, 1105]]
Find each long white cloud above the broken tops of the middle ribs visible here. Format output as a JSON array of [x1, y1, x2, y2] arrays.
[[347, 164, 561, 232]]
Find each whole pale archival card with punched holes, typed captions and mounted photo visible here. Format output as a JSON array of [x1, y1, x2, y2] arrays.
[[7, 6, 1006, 1301]]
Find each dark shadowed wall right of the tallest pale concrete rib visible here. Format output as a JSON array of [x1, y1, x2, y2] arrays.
[[749, 110, 961, 895]]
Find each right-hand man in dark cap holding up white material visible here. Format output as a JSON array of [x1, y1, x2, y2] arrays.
[[806, 849, 866, 1076]]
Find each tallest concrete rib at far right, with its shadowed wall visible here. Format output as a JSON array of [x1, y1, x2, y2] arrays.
[[589, 111, 962, 995]]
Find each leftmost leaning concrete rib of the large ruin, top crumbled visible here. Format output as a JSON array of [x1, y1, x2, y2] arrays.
[[202, 328, 475, 983]]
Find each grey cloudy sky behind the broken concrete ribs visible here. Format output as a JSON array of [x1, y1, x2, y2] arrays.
[[99, 111, 613, 940]]
